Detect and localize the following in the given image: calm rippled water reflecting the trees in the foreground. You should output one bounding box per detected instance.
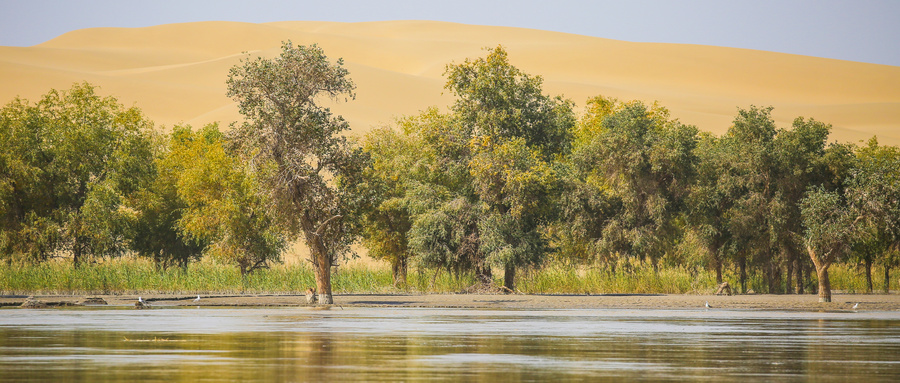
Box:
[0,308,900,382]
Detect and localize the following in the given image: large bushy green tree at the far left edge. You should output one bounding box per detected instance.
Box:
[0,83,153,266]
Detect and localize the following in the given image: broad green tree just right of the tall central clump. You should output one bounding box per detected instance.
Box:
[573,99,697,272]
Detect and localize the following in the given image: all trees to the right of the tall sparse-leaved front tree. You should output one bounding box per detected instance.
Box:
[359,47,900,301]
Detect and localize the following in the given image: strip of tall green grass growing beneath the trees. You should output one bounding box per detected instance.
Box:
[0,257,888,295]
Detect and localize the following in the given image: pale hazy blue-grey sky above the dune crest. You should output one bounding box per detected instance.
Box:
[0,0,900,66]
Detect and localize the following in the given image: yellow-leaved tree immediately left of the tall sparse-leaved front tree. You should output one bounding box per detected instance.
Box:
[170,124,285,276]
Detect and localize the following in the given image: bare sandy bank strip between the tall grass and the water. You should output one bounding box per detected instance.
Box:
[0,294,900,311]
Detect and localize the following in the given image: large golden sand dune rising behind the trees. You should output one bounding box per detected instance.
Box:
[0,21,900,145]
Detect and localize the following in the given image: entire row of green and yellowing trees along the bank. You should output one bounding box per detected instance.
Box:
[0,42,900,303]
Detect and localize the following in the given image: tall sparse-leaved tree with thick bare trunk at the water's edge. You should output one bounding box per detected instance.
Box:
[226,41,363,304]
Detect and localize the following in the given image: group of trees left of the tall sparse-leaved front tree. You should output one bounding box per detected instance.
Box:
[0,84,285,272]
